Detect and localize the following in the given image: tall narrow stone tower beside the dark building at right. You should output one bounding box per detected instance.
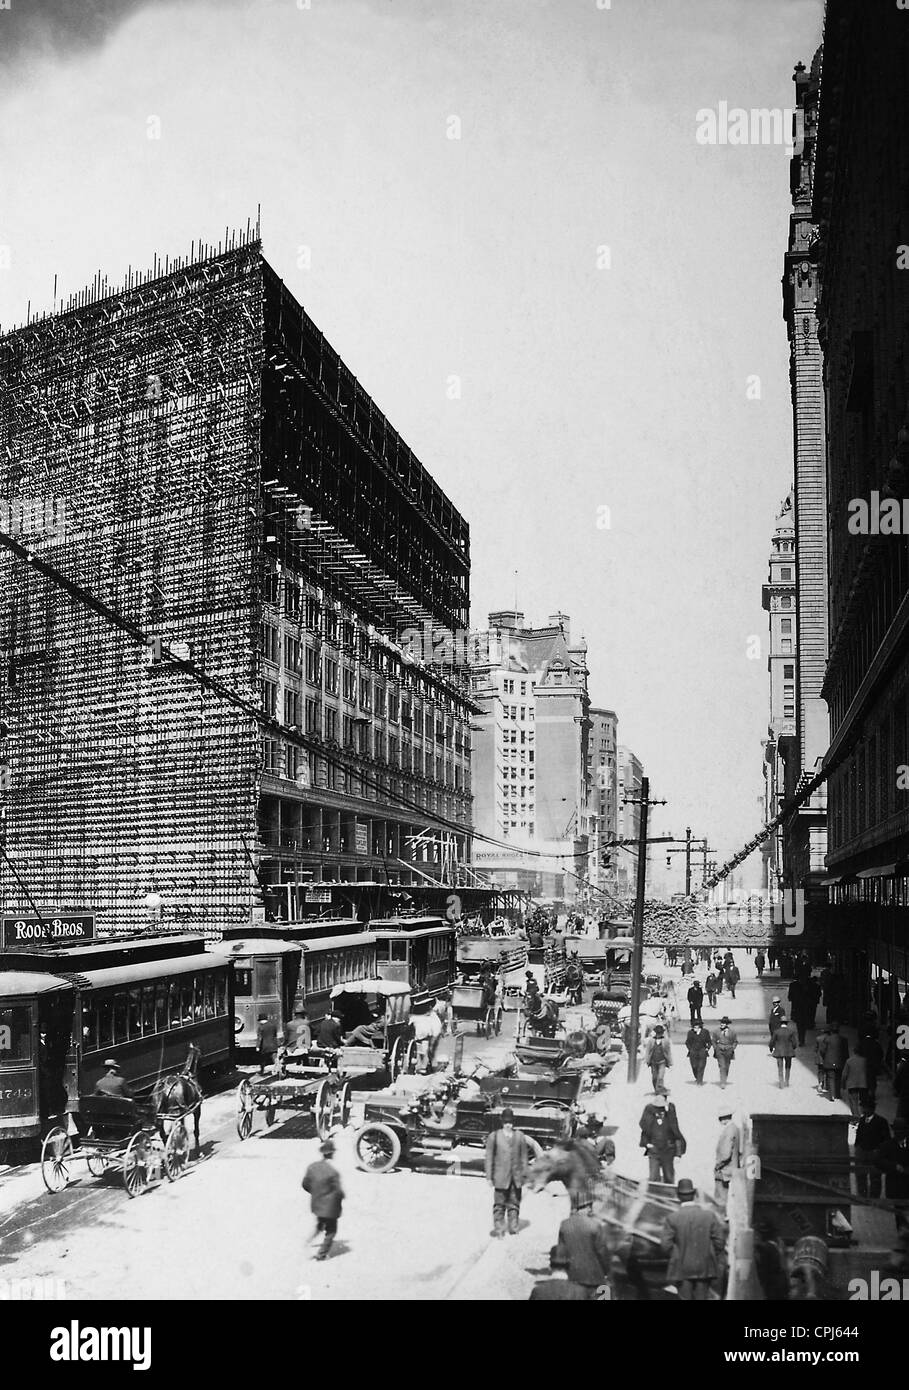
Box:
[769,51,830,899]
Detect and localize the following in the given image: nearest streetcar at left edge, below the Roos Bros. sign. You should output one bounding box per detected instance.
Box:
[0,935,234,1143]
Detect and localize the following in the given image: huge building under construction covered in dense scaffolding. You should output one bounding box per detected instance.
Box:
[0,236,471,930]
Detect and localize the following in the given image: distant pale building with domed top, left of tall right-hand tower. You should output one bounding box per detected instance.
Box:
[762,493,798,892]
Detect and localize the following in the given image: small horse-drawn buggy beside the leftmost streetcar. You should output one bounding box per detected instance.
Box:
[42,1095,190,1197]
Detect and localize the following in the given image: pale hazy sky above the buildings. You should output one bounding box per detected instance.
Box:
[0,0,823,890]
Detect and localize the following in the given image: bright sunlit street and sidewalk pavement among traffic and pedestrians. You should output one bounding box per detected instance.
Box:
[0,951,845,1301]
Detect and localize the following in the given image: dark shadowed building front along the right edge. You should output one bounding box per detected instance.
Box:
[812,0,909,1008]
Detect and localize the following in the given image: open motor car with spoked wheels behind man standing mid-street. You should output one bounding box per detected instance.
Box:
[353,1077,580,1173]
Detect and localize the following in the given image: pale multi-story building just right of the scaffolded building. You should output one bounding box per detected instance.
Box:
[473,610,589,899]
